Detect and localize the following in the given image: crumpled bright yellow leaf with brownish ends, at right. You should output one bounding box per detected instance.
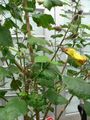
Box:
[62,48,88,65]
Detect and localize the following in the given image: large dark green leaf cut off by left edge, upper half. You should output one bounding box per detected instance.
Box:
[0,25,13,47]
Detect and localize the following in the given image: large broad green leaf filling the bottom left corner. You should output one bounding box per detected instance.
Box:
[0,98,27,120]
